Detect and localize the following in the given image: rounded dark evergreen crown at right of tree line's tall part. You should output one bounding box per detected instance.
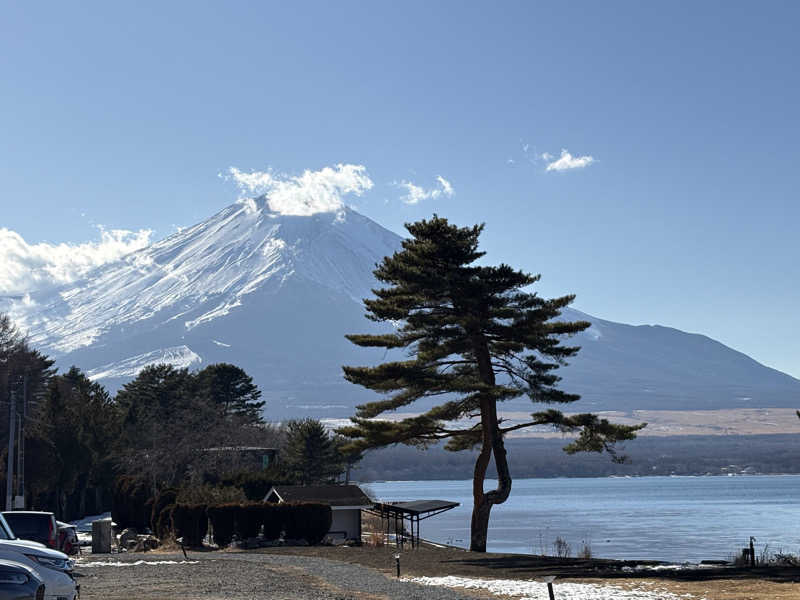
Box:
[195,363,265,423]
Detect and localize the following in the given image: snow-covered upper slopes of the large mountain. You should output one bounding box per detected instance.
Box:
[14,197,400,355]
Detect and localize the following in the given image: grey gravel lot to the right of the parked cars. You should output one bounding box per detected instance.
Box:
[76,552,497,600]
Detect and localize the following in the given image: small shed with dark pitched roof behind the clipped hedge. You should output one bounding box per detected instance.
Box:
[264,484,374,541]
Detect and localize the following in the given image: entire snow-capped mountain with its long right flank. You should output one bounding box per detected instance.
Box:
[0,197,800,419]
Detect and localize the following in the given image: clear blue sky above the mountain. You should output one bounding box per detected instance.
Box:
[0,2,800,376]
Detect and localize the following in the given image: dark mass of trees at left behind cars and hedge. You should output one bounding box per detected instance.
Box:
[0,315,360,520]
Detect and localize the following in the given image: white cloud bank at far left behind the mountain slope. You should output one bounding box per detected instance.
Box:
[0,227,153,295]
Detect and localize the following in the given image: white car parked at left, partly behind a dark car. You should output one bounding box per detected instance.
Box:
[0,515,79,600]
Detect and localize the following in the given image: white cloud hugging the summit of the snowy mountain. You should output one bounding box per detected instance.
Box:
[228,164,373,216]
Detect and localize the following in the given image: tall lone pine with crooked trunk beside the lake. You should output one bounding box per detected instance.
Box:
[339,215,644,552]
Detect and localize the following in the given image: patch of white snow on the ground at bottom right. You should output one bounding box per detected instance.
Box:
[406,576,706,600]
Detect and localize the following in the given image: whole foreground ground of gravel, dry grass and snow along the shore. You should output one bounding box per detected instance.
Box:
[76,546,800,600]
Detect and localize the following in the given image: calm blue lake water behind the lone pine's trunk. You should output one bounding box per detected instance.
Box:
[365,475,800,562]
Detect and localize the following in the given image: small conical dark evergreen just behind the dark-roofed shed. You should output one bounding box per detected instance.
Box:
[281,419,345,485]
